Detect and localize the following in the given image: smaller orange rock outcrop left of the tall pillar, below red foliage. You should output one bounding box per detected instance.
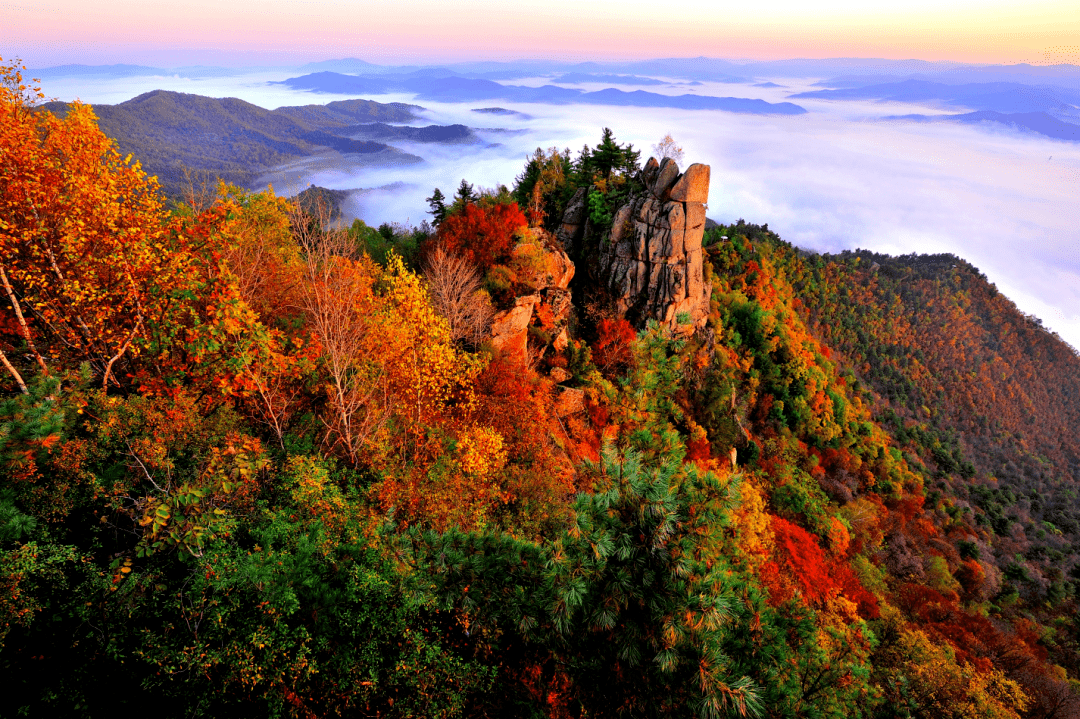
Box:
[491,229,575,364]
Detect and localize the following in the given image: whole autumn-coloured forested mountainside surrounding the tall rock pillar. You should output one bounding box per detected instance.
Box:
[6,60,1080,719]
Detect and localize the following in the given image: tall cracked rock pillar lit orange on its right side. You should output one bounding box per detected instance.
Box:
[599,158,712,335]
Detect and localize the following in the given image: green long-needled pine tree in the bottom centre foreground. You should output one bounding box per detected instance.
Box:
[414,440,761,717]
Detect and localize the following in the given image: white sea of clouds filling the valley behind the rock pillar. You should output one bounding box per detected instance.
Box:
[44,70,1080,348]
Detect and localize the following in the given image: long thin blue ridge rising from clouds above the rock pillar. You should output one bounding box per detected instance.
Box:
[280,71,806,114]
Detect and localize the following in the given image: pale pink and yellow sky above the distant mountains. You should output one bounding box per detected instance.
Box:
[6,0,1080,67]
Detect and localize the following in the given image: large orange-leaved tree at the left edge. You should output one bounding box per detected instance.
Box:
[0,58,191,385]
